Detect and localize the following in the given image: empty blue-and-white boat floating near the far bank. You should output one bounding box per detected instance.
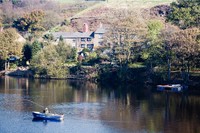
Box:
[157,84,186,92]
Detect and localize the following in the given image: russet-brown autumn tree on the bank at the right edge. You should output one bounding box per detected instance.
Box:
[162,28,200,80]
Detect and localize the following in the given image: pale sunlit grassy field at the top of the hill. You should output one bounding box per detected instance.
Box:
[54,0,175,17]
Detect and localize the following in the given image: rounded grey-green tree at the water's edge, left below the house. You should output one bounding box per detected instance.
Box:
[31,45,68,78]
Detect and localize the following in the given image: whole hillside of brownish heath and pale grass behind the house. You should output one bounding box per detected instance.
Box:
[0,0,173,32]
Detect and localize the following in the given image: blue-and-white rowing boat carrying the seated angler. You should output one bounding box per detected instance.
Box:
[32,111,64,121]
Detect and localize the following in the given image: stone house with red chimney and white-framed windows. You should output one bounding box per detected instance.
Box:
[52,24,106,51]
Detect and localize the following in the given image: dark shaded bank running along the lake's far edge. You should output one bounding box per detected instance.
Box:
[0,66,200,90]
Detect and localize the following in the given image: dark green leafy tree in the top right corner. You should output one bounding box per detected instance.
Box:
[167,0,200,29]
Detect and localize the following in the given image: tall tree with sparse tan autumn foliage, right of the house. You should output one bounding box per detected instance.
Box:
[105,10,146,66]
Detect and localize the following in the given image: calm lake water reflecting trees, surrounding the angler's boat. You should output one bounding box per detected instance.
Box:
[0,77,200,133]
